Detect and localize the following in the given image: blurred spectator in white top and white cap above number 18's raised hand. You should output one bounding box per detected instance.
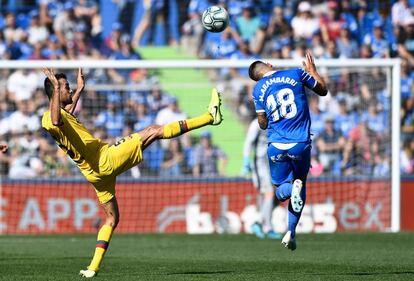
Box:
[291,1,320,41]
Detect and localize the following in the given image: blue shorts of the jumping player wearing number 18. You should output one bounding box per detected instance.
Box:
[267,142,312,185]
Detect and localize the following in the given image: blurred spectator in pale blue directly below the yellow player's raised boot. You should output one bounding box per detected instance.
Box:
[193,132,227,177]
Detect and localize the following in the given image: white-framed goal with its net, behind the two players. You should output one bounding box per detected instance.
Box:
[0,59,400,234]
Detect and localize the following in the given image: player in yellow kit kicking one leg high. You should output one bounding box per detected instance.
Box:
[42,68,222,278]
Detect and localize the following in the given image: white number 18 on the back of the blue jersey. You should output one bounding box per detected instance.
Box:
[266,88,298,121]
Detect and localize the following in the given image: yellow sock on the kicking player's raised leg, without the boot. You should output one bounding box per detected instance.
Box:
[163,113,213,139]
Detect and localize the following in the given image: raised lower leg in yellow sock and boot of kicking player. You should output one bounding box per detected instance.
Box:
[161,89,223,139]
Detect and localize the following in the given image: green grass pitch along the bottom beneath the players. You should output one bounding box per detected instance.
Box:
[0,233,414,281]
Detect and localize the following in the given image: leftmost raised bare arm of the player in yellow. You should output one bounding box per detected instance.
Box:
[43,68,62,126]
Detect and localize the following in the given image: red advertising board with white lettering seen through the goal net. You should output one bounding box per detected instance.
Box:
[0,178,391,234]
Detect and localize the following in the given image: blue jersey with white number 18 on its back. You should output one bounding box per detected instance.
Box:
[253,68,317,143]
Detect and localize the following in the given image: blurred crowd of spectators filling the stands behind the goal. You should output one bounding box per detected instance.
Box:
[0,0,414,178]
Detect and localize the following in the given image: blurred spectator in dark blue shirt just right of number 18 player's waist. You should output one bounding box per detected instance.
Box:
[316,117,345,174]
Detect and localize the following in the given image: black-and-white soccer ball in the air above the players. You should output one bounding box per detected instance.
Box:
[201,6,229,32]
